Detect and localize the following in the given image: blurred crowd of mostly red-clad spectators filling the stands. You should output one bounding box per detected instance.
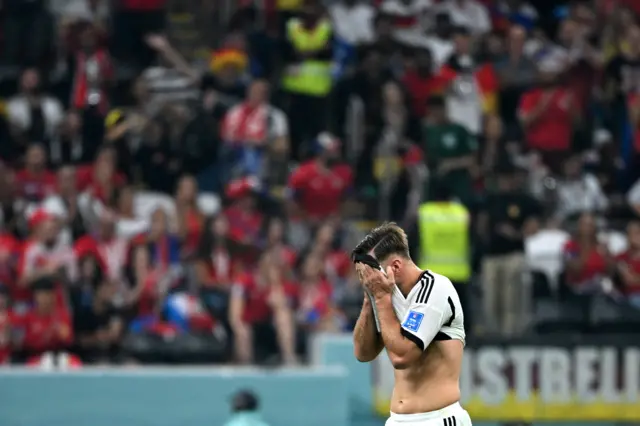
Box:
[0,0,640,364]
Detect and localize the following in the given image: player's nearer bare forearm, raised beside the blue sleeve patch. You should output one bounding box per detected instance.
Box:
[375,294,419,365]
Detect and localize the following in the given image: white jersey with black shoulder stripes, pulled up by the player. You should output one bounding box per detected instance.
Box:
[391,270,465,350]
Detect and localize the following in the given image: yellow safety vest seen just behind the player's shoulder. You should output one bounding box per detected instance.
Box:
[418,202,471,282]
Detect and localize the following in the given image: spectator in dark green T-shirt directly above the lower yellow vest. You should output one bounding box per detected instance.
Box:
[422,96,478,205]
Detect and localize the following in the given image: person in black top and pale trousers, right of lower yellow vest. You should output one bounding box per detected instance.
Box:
[478,160,542,336]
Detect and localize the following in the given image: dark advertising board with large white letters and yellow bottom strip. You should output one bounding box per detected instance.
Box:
[374,338,640,421]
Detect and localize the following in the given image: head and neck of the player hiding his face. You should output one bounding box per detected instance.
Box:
[351,222,422,288]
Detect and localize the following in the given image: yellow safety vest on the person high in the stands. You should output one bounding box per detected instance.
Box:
[282,19,331,97]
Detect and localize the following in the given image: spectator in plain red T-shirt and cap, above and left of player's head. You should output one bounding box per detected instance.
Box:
[288,133,353,223]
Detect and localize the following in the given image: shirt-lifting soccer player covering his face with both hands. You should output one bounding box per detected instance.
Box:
[352,223,471,426]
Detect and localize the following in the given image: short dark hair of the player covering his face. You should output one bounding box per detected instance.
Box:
[351,222,411,262]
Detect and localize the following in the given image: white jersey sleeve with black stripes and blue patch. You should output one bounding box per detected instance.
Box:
[400,274,452,351]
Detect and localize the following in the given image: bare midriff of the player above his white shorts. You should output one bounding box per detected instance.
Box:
[391,340,463,414]
